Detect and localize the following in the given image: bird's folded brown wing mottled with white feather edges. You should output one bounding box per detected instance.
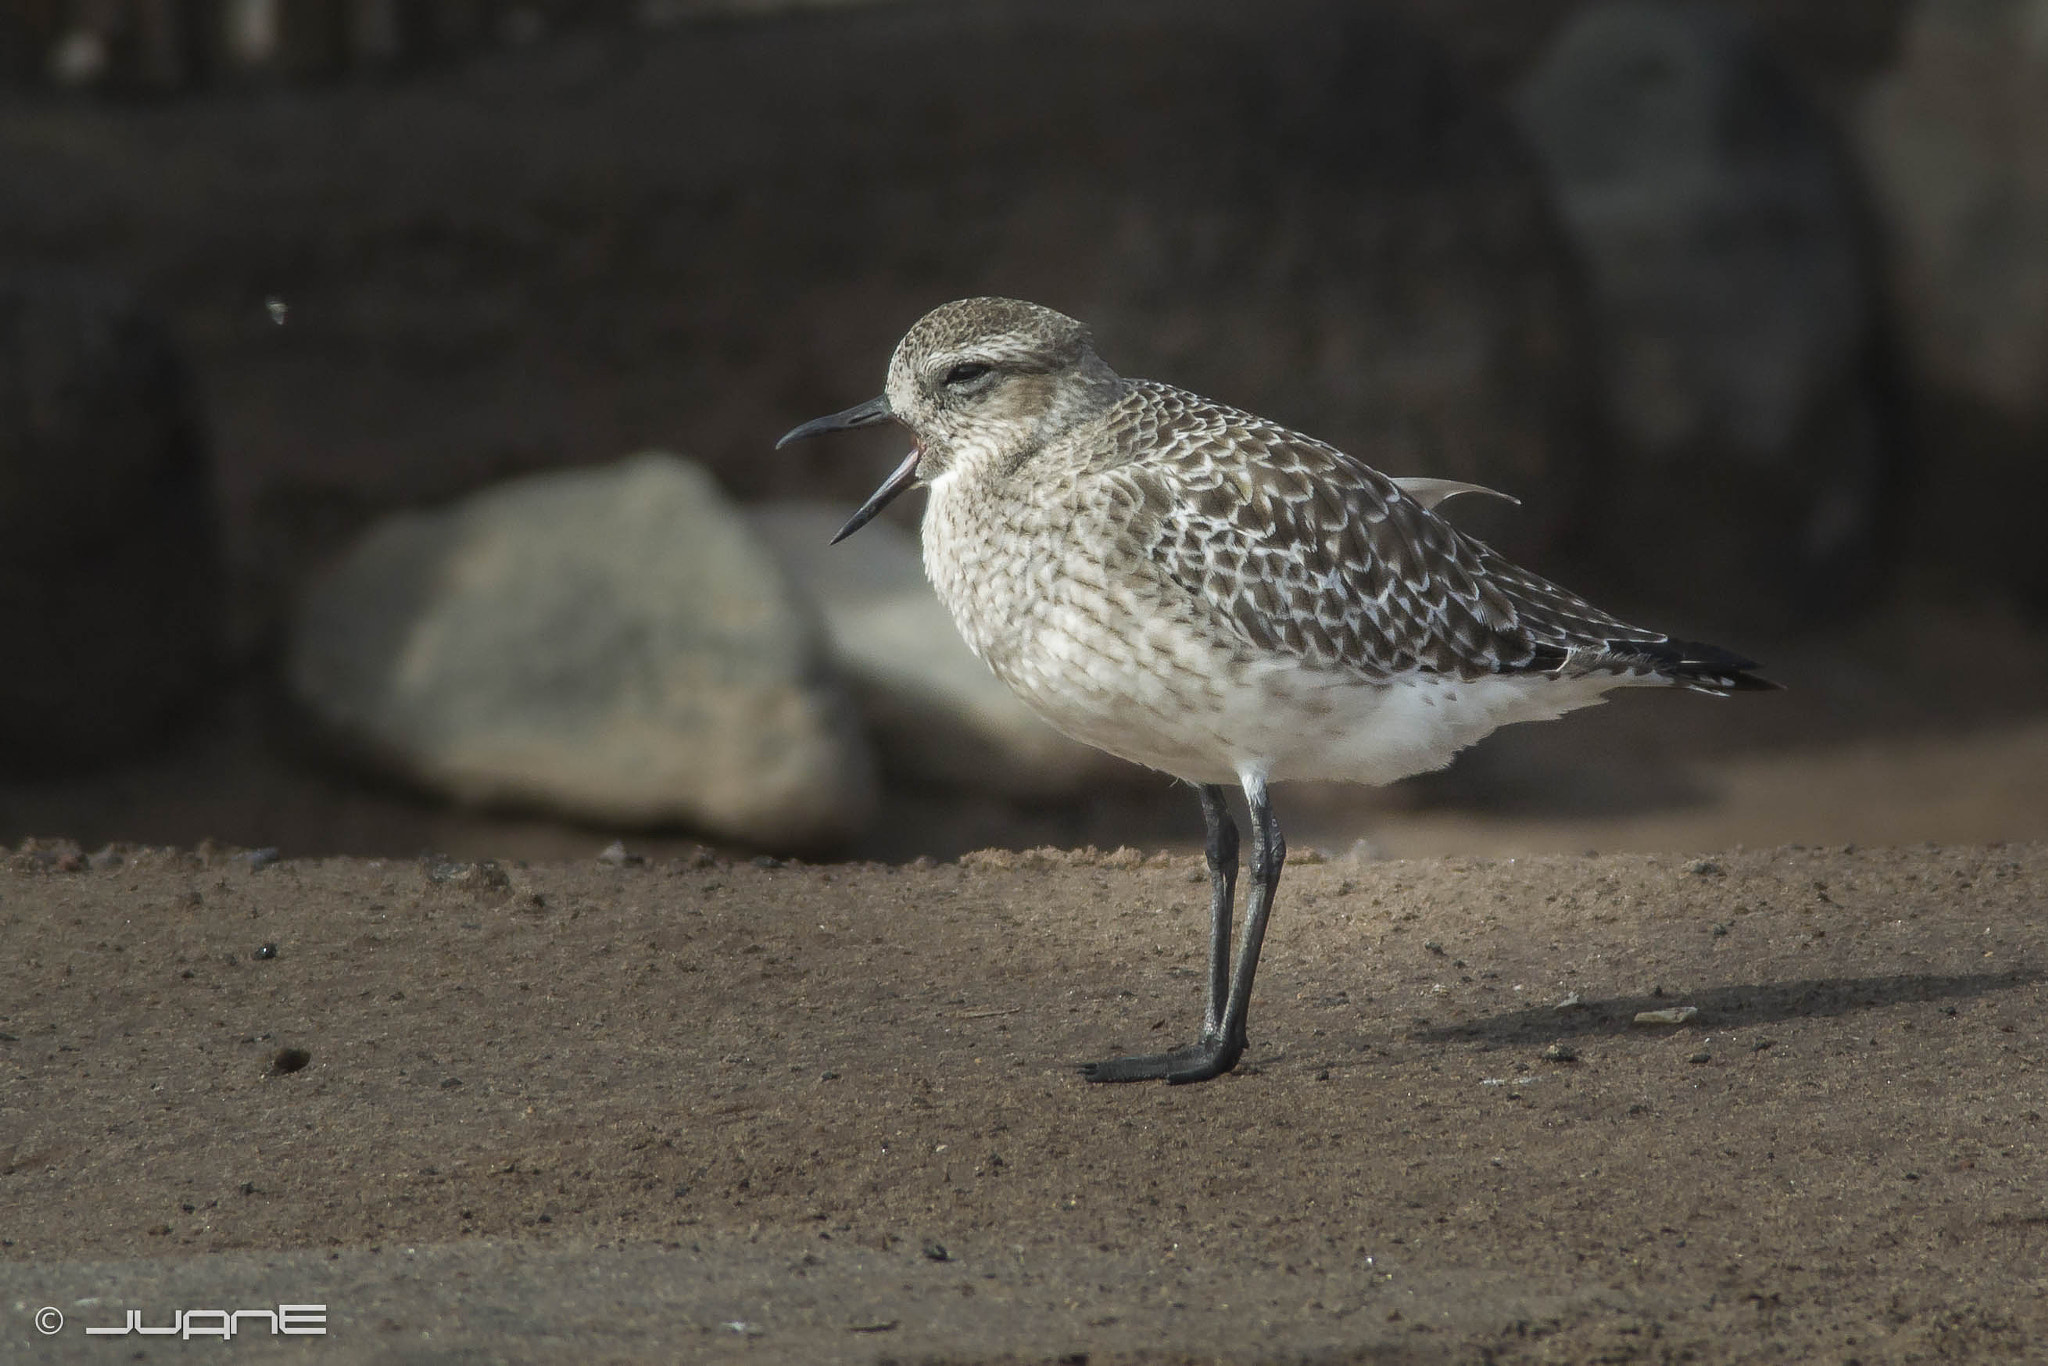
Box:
[1100,383,1749,690]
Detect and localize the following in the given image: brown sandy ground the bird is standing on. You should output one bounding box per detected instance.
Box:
[0,844,2048,1366]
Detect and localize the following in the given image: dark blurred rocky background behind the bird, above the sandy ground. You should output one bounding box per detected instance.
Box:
[0,0,2048,858]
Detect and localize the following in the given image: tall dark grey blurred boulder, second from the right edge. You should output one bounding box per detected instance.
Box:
[1516,2,1898,616]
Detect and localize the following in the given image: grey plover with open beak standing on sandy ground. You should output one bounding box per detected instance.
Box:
[776,299,1776,1081]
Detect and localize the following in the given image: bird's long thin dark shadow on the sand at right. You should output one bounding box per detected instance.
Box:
[1409,967,2048,1044]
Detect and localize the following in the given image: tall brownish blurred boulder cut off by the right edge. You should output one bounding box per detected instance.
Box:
[1860,0,2048,612]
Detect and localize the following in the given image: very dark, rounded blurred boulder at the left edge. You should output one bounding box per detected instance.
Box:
[0,272,221,770]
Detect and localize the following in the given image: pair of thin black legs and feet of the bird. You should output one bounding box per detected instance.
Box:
[1081,778,1286,1083]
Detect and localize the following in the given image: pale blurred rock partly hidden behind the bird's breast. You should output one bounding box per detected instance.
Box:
[750,502,1139,801]
